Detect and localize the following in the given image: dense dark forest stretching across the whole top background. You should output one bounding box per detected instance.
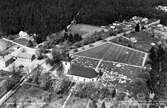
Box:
[0,0,167,43]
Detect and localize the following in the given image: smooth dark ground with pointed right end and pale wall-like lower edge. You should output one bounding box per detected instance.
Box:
[68,64,98,78]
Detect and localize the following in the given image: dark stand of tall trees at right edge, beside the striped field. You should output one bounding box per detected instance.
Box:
[147,46,167,101]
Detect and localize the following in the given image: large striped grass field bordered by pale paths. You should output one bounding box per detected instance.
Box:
[74,43,145,66]
